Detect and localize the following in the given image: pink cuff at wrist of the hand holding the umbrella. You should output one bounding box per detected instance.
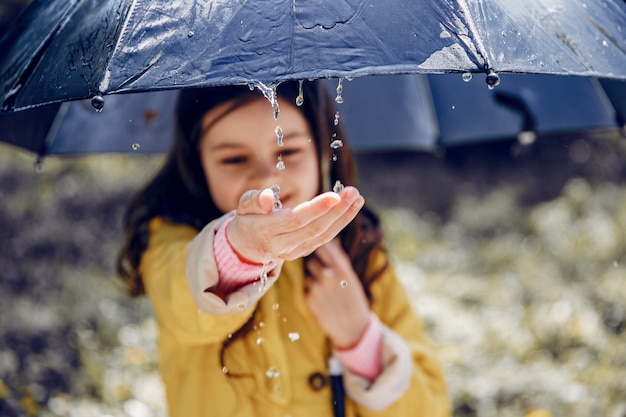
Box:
[333,313,383,382]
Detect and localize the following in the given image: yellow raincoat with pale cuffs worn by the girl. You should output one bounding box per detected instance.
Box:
[141,214,449,417]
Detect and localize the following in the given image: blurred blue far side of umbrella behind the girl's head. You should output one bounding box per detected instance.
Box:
[0,74,626,155]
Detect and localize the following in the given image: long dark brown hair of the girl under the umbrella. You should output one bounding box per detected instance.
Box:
[117,81,382,298]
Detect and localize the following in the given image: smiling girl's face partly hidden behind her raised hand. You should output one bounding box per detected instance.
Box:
[200,97,319,213]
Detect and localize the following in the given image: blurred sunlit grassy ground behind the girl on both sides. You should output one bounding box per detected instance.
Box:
[0,131,626,417]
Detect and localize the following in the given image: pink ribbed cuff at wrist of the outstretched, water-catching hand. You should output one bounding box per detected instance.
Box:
[213,217,274,294]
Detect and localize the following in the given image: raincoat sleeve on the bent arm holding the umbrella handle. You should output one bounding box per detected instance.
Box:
[344,251,450,417]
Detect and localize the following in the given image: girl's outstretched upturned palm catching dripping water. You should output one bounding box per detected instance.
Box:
[226,187,364,263]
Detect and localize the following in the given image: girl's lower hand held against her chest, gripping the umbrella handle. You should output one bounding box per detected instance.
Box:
[306,239,370,349]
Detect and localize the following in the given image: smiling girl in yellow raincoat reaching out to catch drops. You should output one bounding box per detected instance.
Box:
[118,82,449,417]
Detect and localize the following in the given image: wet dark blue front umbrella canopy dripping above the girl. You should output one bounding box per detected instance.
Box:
[0,0,626,112]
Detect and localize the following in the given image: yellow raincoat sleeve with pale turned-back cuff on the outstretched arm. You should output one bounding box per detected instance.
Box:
[140,214,281,345]
